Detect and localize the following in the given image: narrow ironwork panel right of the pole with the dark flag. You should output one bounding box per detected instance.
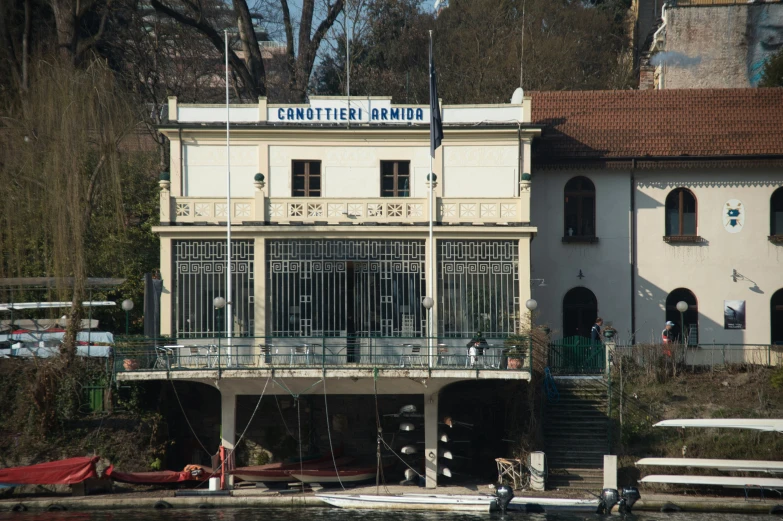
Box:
[437,240,519,337]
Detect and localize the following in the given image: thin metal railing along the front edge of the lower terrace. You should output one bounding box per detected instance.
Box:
[114,337,532,373]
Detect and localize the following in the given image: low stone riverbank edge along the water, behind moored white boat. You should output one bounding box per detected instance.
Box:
[0,486,783,514]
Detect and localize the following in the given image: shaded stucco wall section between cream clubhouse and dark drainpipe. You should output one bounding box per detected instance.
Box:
[531,170,631,341]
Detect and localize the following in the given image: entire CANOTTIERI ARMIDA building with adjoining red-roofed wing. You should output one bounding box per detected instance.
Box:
[118,89,783,487]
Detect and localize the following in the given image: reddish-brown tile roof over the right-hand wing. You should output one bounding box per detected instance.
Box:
[530,88,783,162]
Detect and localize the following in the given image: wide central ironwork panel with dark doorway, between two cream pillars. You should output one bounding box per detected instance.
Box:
[267,240,426,337]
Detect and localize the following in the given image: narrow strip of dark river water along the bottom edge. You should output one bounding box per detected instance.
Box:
[0,507,780,521]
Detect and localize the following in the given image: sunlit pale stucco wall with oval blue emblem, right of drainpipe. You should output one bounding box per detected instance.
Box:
[636,170,783,344]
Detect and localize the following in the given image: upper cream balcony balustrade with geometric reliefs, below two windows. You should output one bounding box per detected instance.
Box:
[161,196,530,224]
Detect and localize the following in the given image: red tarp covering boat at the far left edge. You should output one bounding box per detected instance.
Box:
[0,456,100,485]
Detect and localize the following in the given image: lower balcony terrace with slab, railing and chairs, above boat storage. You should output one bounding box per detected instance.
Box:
[114,337,532,380]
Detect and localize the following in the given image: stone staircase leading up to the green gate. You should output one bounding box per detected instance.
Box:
[543,376,610,493]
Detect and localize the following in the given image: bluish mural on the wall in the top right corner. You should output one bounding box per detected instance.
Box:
[745,3,783,87]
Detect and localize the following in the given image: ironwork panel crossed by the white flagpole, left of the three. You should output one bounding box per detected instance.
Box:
[174,240,254,338]
